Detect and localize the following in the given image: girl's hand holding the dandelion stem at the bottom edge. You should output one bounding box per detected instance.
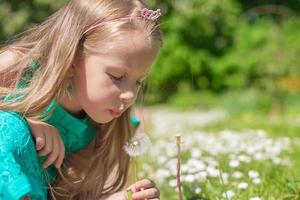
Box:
[128,179,160,200]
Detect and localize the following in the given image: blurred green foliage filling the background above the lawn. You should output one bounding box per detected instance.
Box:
[0,0,300,107]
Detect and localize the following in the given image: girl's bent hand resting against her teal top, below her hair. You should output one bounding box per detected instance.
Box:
[27,119,65,168]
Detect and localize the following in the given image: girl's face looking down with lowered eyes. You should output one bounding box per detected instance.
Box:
[63,30,159,123]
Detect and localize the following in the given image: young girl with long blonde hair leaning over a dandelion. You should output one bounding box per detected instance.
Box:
[0,0,162,200]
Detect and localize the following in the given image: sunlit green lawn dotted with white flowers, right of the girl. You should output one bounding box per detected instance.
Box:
[142,91,300,200]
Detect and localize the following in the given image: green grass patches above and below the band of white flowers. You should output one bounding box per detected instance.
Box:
[142,91,300,200]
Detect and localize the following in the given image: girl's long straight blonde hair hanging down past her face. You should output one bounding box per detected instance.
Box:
[0,0,162,199]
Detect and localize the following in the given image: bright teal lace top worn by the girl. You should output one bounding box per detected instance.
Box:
[0,62,139,200]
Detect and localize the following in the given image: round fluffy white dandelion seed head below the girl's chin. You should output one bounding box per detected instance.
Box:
[123,133,151,157]
